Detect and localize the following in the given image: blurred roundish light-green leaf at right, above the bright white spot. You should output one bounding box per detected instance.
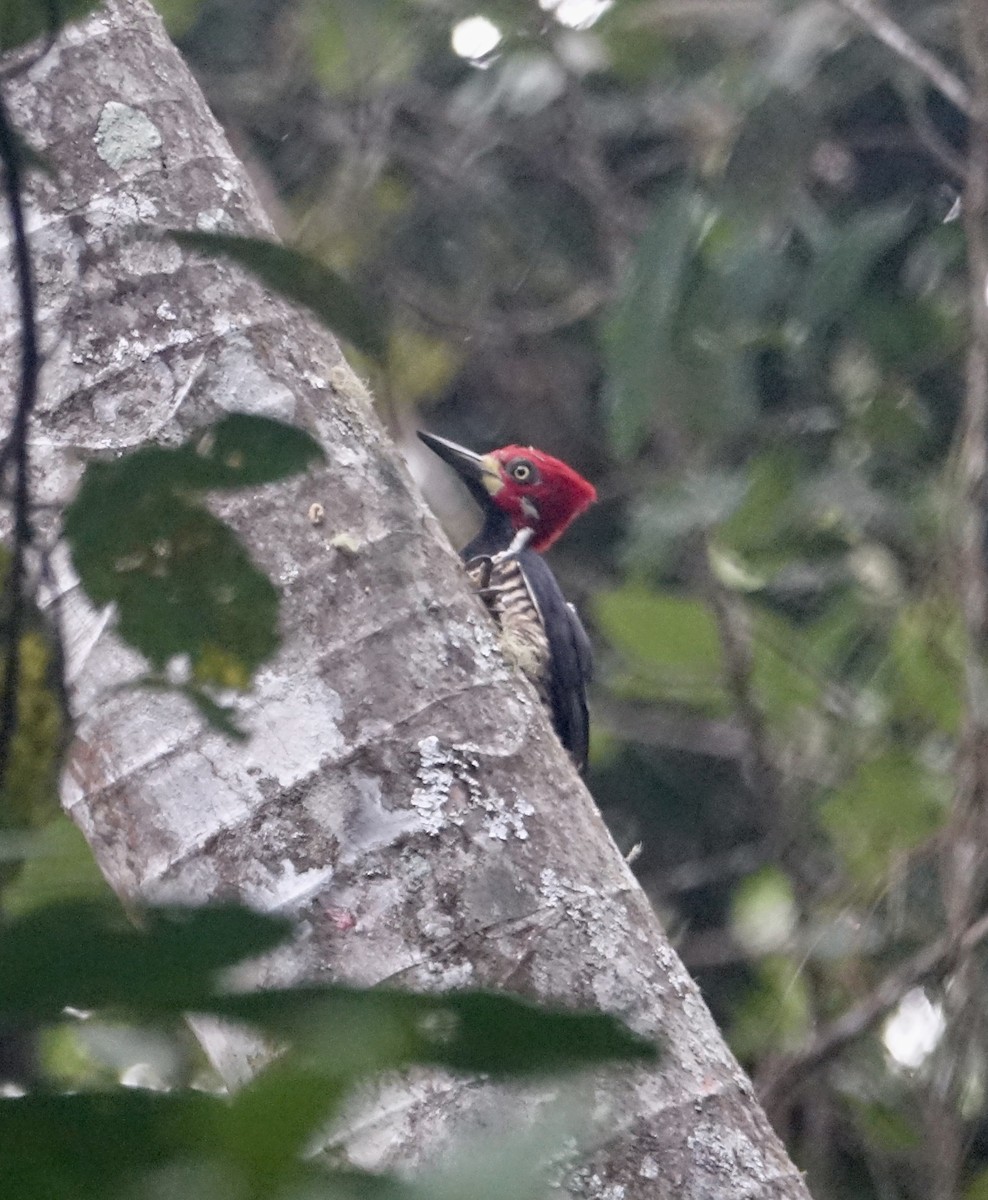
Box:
[820,748,950,888]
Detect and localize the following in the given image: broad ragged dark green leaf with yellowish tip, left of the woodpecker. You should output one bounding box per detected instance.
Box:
[65,414,322,691]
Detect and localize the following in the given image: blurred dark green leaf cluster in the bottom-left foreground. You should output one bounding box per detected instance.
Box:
[0,900,655,1200]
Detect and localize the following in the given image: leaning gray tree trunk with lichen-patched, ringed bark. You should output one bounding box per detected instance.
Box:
[0,0,806,1200]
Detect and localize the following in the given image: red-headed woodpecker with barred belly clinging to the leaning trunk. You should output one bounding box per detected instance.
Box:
[419,433,597,773]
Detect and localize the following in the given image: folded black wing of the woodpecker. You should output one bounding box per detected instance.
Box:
[519,551,593,773]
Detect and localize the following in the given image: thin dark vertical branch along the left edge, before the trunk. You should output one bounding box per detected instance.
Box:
[0,95,41,787]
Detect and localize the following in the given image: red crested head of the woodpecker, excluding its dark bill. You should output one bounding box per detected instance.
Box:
[484,446,597,551]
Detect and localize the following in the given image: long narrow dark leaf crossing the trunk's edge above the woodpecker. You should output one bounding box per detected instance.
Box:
[168,229,385,362]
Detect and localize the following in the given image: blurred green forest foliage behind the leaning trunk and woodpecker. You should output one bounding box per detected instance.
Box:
[6,0,988,1200]
